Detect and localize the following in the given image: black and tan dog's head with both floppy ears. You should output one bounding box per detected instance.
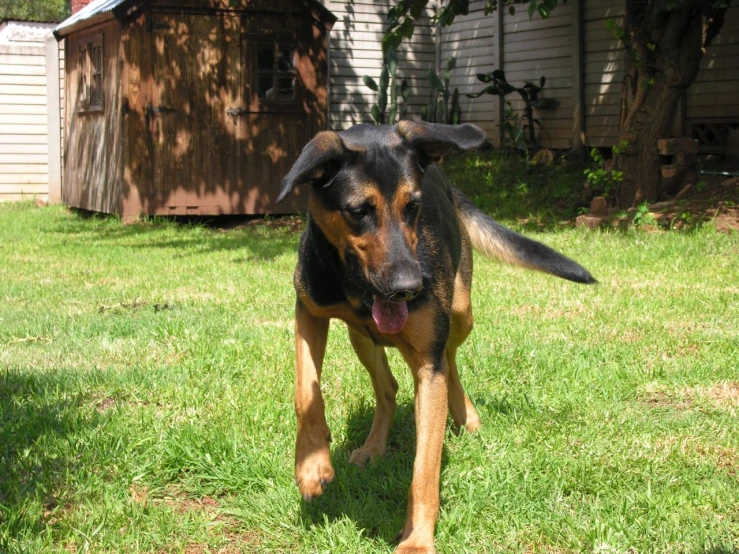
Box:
[277,121,485,328]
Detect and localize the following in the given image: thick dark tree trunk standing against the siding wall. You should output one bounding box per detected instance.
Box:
[614,0,731,208]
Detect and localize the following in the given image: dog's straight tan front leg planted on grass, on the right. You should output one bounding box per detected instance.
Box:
[395,355,449,554]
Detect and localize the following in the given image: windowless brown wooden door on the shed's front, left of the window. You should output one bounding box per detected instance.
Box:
[145,13,243,215]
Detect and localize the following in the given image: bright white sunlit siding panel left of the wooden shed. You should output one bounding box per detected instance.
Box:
[0,43,49,201]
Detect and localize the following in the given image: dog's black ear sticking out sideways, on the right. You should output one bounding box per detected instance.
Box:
[396,121,485,162]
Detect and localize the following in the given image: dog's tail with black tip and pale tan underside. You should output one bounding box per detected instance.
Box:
[453,188,597,283]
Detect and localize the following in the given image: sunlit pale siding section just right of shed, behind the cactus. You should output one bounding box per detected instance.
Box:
[324,0,436,130]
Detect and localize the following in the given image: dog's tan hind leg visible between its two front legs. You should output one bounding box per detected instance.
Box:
[348,327,398,467]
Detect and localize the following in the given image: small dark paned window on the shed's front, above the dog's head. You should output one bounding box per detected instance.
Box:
[257,43,296,102]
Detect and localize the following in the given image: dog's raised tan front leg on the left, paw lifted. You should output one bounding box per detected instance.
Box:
[295,301,334,502]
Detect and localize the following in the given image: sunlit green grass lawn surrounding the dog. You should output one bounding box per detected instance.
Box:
[0,191,739,554]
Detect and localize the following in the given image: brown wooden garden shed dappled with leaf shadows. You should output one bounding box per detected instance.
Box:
[55,0,336,217]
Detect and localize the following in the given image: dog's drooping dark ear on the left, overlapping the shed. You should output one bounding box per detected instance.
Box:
[277,131,344,203]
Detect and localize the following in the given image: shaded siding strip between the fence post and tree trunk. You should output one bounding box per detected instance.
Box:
[583,0,626,146]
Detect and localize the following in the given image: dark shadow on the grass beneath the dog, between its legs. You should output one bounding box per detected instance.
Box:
[301,402,448,545]
